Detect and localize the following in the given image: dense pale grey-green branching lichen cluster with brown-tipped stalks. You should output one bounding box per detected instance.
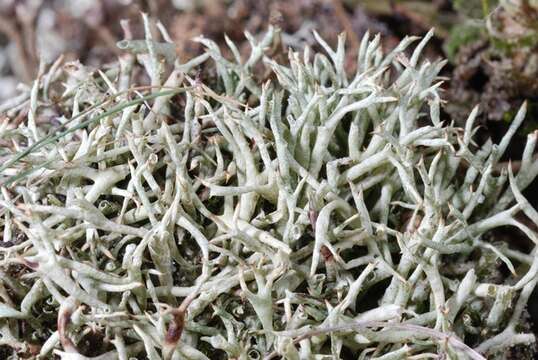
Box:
[0,19,538,360]
